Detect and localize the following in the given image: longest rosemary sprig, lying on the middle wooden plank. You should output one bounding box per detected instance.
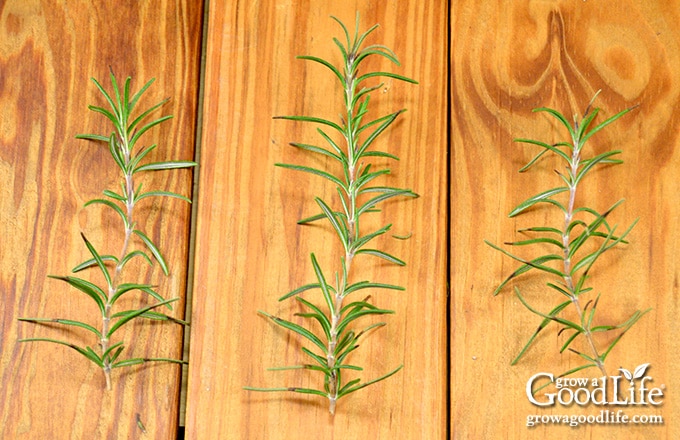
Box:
[245,15,417,414]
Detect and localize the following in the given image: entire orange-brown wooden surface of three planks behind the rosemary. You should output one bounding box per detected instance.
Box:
[5,0,680,439]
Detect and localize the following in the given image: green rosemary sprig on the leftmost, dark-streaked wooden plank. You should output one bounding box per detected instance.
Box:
[19,72,196,390]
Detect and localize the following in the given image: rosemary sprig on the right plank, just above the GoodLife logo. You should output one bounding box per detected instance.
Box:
[486,92,650,382]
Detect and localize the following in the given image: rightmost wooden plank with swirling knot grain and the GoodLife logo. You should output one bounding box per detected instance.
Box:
[450,0,680,439]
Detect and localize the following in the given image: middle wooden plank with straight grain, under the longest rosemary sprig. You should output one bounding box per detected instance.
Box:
[187,0,447,439]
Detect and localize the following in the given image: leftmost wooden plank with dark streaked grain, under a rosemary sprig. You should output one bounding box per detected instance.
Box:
[0,0,202,439]
